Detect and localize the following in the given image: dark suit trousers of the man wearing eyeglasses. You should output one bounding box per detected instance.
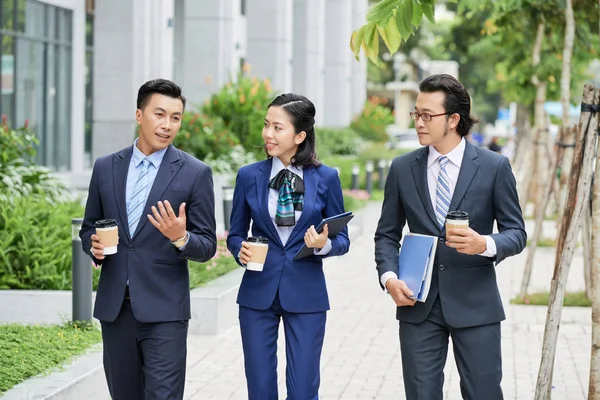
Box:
[400,297,503,400]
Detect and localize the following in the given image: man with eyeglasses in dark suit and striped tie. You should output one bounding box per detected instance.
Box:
[375,74,527,400]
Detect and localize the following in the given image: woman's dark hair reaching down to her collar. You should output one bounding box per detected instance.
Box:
[265,93,321,167]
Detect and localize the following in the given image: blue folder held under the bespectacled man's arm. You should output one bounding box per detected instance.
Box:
[398,233,438,302]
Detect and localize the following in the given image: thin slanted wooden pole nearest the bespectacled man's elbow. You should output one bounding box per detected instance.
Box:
[519,129,565,298]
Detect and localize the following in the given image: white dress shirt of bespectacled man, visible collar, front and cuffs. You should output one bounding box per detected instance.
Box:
[381,138,496,287]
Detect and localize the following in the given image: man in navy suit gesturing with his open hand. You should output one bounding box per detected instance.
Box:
[80,79,217,400]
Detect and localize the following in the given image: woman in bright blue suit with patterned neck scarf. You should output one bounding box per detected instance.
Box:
[227,93,350,400]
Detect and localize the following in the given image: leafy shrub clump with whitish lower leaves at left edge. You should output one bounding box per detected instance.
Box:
[0,124,67,202]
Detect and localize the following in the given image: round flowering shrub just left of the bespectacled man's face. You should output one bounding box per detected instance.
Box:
[350,97,394,142]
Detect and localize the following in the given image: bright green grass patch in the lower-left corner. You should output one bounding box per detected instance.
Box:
[0,322,102,393]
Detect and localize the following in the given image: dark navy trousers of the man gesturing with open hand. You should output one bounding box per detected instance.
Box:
[100,299,188,400]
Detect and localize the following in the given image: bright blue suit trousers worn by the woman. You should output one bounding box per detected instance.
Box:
[239,295,326,400]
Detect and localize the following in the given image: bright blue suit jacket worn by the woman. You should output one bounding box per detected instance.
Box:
[227,158,350,313]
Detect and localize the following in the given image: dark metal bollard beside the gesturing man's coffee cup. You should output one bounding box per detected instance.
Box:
[71,218,92,321]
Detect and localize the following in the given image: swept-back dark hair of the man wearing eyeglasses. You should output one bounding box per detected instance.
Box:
[419,74,479,137]
